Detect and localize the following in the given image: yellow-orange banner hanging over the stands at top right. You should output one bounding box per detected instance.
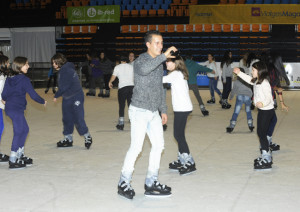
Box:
[190,4,300,24]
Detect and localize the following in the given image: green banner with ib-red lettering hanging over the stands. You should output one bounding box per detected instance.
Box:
[67,5,120,24]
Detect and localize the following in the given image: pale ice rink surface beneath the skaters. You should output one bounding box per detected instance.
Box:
[0,89,300,212]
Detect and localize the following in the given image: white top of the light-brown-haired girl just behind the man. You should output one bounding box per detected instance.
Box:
[163,70,193,112]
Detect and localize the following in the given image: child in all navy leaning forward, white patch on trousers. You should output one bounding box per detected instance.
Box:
[51,53,92,149]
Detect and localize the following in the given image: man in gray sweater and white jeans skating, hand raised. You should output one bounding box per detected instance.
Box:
[118,31,177,199]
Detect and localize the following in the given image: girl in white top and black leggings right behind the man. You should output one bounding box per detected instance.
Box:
[163,56,196,175]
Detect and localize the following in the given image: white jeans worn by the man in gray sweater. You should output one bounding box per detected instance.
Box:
[120,105,164,182]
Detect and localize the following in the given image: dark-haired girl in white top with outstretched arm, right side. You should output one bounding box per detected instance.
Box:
[234,61,275,169]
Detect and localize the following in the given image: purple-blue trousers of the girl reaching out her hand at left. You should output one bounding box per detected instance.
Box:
[5,108,29,152]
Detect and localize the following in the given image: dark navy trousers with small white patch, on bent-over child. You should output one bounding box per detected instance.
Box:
[62,92,88,135]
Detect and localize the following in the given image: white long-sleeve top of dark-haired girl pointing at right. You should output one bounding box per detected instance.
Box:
[238,72,274,110]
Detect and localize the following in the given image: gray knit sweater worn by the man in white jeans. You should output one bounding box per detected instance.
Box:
[131,52,167,114]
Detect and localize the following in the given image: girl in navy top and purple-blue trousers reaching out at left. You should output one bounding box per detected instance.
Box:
[2,57,47,169]
